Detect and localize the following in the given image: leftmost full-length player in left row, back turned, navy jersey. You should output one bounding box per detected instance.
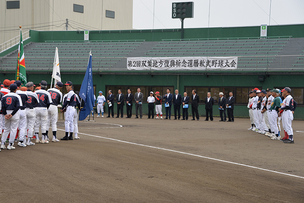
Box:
[0,84,22,150]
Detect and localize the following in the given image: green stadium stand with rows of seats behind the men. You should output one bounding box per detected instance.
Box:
[0,25,304,119]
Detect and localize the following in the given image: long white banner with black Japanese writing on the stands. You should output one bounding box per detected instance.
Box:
[127,57,238,70]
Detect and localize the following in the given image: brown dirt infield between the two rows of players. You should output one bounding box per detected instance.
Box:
[0,117,304,202]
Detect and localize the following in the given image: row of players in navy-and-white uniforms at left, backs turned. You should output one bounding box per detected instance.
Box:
[0,79,80,151]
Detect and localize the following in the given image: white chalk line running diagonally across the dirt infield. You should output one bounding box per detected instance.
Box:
[58,128,304,179]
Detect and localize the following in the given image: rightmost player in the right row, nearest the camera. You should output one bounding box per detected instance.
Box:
[279,87,294,144]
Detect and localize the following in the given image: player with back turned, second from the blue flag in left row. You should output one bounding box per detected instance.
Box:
[46,82,63,142]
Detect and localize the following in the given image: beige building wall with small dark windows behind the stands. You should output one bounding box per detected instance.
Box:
[0,0,133,44]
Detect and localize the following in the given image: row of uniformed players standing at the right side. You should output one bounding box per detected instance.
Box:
[247,87,297,144]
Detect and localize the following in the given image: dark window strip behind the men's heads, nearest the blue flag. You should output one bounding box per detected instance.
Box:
[104,85,174,102]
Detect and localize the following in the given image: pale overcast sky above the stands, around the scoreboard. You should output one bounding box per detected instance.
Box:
[133,0,304,29]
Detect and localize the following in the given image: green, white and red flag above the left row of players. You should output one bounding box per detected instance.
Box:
[16,26,27,84]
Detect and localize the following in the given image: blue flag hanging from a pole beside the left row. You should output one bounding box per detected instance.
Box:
[79,52,94,121]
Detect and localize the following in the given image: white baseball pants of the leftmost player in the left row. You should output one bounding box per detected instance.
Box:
[1,110,20,145]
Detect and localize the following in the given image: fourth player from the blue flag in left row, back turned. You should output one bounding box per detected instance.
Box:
[25,82,39,146]
